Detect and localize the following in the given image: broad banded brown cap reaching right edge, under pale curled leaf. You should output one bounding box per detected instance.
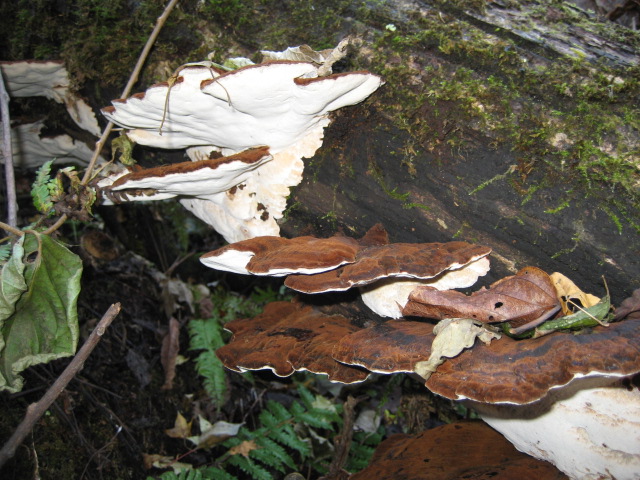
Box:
[426,320,640,404]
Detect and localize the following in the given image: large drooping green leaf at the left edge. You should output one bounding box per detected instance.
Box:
[0,234,82,392]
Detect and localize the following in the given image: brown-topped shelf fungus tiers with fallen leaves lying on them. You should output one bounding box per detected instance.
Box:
[201,226,640,479]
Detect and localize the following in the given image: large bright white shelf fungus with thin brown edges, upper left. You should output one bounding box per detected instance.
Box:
[100,43,383,242]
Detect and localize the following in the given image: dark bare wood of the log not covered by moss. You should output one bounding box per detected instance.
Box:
[282,2,640,303]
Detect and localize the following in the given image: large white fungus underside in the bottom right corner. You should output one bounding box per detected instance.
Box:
[469,377,640,480]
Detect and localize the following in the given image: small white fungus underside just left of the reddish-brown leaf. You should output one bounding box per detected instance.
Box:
[359,257,490,318]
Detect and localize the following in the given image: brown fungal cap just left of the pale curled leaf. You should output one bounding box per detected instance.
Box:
[332,320,434,373]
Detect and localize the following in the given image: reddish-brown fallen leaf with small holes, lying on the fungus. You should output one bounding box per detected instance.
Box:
[402,267,560,333]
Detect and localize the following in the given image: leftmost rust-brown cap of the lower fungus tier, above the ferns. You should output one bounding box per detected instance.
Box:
[216,302,369,383]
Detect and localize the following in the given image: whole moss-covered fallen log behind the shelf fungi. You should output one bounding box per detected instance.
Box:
[2,0,640,303]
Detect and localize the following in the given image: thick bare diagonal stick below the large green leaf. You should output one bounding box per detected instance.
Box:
[0,303,120,468]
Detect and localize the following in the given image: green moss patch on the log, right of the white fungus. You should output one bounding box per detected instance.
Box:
[358,2,640,234]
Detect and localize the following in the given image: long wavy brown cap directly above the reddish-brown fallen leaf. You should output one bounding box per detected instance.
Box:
[285,242,491,293]
